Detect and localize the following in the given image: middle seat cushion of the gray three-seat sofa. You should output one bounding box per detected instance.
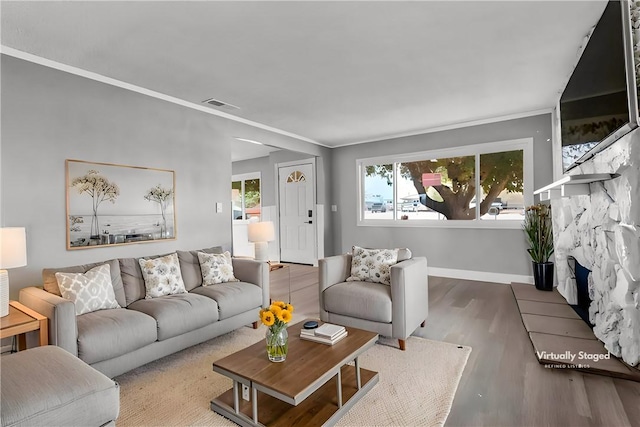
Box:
[129,294,218,341]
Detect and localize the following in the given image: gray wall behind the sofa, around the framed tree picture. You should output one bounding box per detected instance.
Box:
[0,55,336,299]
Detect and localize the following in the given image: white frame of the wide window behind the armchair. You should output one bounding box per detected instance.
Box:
[356,138,533,229]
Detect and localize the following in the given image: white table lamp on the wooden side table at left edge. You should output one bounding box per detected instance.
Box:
[0,227,27,317]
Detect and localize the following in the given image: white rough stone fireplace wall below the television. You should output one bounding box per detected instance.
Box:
[551,129,640,366]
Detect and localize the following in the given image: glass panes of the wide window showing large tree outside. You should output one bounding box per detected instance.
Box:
[364,145,524,220]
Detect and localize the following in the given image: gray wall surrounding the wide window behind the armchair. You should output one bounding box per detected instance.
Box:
[330,114,552,276]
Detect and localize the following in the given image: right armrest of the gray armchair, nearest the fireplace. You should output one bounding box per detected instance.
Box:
[391,257,429,339]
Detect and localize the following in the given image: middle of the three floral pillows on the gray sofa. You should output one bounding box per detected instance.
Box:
[138,253,187,299]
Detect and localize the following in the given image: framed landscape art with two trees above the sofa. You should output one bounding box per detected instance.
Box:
[65,159,176,250]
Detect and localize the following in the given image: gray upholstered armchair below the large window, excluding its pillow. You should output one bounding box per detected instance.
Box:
[319,254,429,350]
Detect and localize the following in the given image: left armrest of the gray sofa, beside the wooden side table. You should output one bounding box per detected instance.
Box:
[18,286,78,356]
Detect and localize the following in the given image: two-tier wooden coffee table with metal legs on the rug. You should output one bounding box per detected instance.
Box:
[211,322,378,426]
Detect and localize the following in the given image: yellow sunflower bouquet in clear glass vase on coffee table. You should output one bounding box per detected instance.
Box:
[260,301,293,362]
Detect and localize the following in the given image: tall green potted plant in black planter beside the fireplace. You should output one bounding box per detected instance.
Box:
[523,203,553,291]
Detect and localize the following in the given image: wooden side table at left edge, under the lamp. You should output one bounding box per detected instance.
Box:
[0,301,49,350]
